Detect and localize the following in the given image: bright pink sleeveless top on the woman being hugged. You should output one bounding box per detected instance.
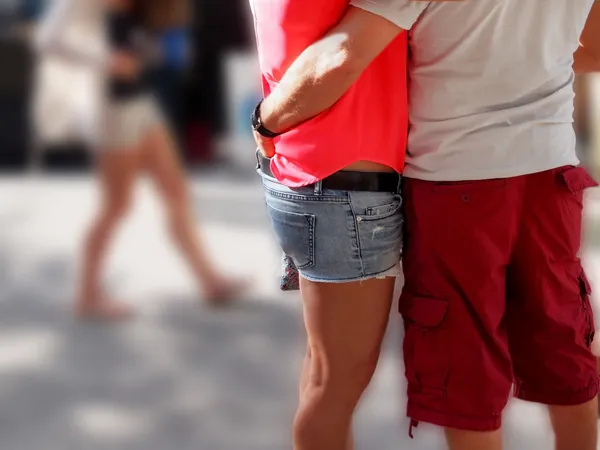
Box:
[251,0,408,187]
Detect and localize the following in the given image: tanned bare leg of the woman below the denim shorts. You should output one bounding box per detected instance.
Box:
[294,278,395,450]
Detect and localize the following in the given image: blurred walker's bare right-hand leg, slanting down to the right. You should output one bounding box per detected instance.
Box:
[144,119,245,302]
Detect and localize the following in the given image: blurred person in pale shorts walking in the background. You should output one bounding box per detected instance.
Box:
[36,0,243,320]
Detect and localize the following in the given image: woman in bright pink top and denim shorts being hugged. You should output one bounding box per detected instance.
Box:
[251,0,408,450]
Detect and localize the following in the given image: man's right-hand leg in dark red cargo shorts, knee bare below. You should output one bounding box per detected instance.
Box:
[506,167,599,450]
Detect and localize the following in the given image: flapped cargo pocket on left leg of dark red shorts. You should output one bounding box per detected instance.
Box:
[400,294,450,396]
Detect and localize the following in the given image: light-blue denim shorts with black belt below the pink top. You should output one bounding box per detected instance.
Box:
[258,169,403,283]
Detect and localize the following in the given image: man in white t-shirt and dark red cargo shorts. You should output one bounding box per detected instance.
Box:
[251,0,600,450]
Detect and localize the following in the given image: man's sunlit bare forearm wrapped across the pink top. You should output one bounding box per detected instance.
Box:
[260,6,402,132]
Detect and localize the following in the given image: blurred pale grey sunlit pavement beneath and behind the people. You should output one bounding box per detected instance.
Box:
[0,171,600,450]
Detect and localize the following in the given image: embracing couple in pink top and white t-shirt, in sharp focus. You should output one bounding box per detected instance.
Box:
[250,0,600,450]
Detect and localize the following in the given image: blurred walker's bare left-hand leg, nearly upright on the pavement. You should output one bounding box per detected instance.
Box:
[76,149,141,319]
